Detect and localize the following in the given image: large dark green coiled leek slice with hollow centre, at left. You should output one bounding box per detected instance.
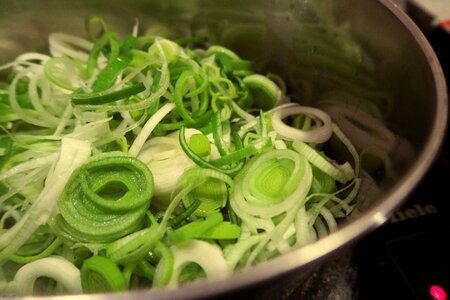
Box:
[58,152,153,243]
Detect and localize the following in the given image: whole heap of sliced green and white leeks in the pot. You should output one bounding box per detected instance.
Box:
[0,16,383,295]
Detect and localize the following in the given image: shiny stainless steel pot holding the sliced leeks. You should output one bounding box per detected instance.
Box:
[0,0,448,299]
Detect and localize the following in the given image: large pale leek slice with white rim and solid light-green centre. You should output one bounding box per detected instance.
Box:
[230,149,312,220]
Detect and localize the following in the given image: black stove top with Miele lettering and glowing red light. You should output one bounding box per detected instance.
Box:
[353,149,450,300]
